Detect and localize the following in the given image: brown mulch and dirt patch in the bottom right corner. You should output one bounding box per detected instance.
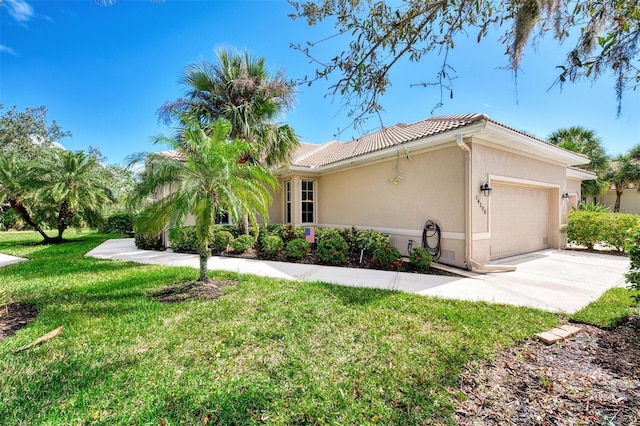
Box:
[455,317,640,425]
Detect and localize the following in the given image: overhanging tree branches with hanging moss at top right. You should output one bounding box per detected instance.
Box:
[289,0,640,121]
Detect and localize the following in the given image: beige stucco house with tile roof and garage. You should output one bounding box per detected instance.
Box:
[269,114,595,269]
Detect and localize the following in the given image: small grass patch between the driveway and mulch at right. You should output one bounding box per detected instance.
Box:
[571,287,638,329]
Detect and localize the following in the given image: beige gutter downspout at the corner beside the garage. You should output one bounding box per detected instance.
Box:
[456,134,516,273]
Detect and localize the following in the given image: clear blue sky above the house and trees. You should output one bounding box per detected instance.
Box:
[0,0,640,163]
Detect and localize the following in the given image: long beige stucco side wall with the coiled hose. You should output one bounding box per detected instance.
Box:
[317,146,464,266]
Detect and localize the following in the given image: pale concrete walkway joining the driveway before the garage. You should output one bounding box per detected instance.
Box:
[87,239,629,313]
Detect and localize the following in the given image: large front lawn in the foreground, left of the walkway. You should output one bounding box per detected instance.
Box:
[0,233,558,425]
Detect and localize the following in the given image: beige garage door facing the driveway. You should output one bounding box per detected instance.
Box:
[491,183,551,260]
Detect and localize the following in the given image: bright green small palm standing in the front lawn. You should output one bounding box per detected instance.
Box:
[134,117,277,281]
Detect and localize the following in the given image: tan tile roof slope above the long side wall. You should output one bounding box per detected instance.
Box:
[291,114,490,167]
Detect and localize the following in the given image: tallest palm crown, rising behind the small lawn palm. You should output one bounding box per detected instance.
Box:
[158,49,299,166]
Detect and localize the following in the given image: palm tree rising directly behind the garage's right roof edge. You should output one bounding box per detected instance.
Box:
[548,126,609,198]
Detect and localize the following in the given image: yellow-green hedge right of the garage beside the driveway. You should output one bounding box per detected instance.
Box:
[567,210,640,252]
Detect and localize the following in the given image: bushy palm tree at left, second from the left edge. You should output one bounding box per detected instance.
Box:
[35,149,116,243]
